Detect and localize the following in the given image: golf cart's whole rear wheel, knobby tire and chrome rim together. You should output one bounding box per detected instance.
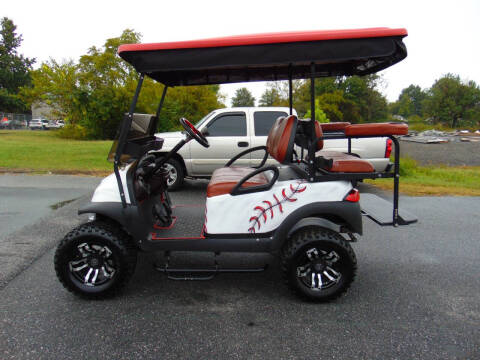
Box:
[281,227,357,302]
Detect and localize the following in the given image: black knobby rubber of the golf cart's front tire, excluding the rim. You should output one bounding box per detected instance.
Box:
[54,221,137,299]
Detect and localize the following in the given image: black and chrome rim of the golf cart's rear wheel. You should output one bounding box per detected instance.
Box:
[296,247,342,291]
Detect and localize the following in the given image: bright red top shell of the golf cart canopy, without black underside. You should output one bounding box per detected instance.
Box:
[118,27,408,54]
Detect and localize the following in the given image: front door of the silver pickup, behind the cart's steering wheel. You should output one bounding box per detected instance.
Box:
[190,111,250,176]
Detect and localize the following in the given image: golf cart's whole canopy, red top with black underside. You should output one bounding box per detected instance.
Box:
[118,28,407,86]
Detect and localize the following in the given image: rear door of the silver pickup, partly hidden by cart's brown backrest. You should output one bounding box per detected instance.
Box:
[251,110,288,166]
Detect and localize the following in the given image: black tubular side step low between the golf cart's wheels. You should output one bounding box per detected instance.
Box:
[154,252,268,281]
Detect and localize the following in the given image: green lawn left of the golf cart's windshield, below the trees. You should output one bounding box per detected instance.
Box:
[0,130,112,175]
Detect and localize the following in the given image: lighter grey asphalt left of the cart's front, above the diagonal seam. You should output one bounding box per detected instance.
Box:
[0,174,101,287]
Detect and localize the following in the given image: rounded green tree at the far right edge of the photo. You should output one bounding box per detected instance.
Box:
[423,74,480,128]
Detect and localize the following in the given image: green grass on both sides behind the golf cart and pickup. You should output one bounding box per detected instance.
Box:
[0,130,480,196]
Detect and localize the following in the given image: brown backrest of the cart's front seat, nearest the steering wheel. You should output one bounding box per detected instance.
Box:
[267,115,298,164]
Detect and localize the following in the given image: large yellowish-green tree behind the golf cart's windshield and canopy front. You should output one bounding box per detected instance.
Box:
[21,30,223,139]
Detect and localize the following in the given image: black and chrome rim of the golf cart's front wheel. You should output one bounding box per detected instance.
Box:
[68,242,117,287]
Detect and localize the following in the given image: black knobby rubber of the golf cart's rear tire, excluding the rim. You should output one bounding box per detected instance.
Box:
[281,227,357,302]
